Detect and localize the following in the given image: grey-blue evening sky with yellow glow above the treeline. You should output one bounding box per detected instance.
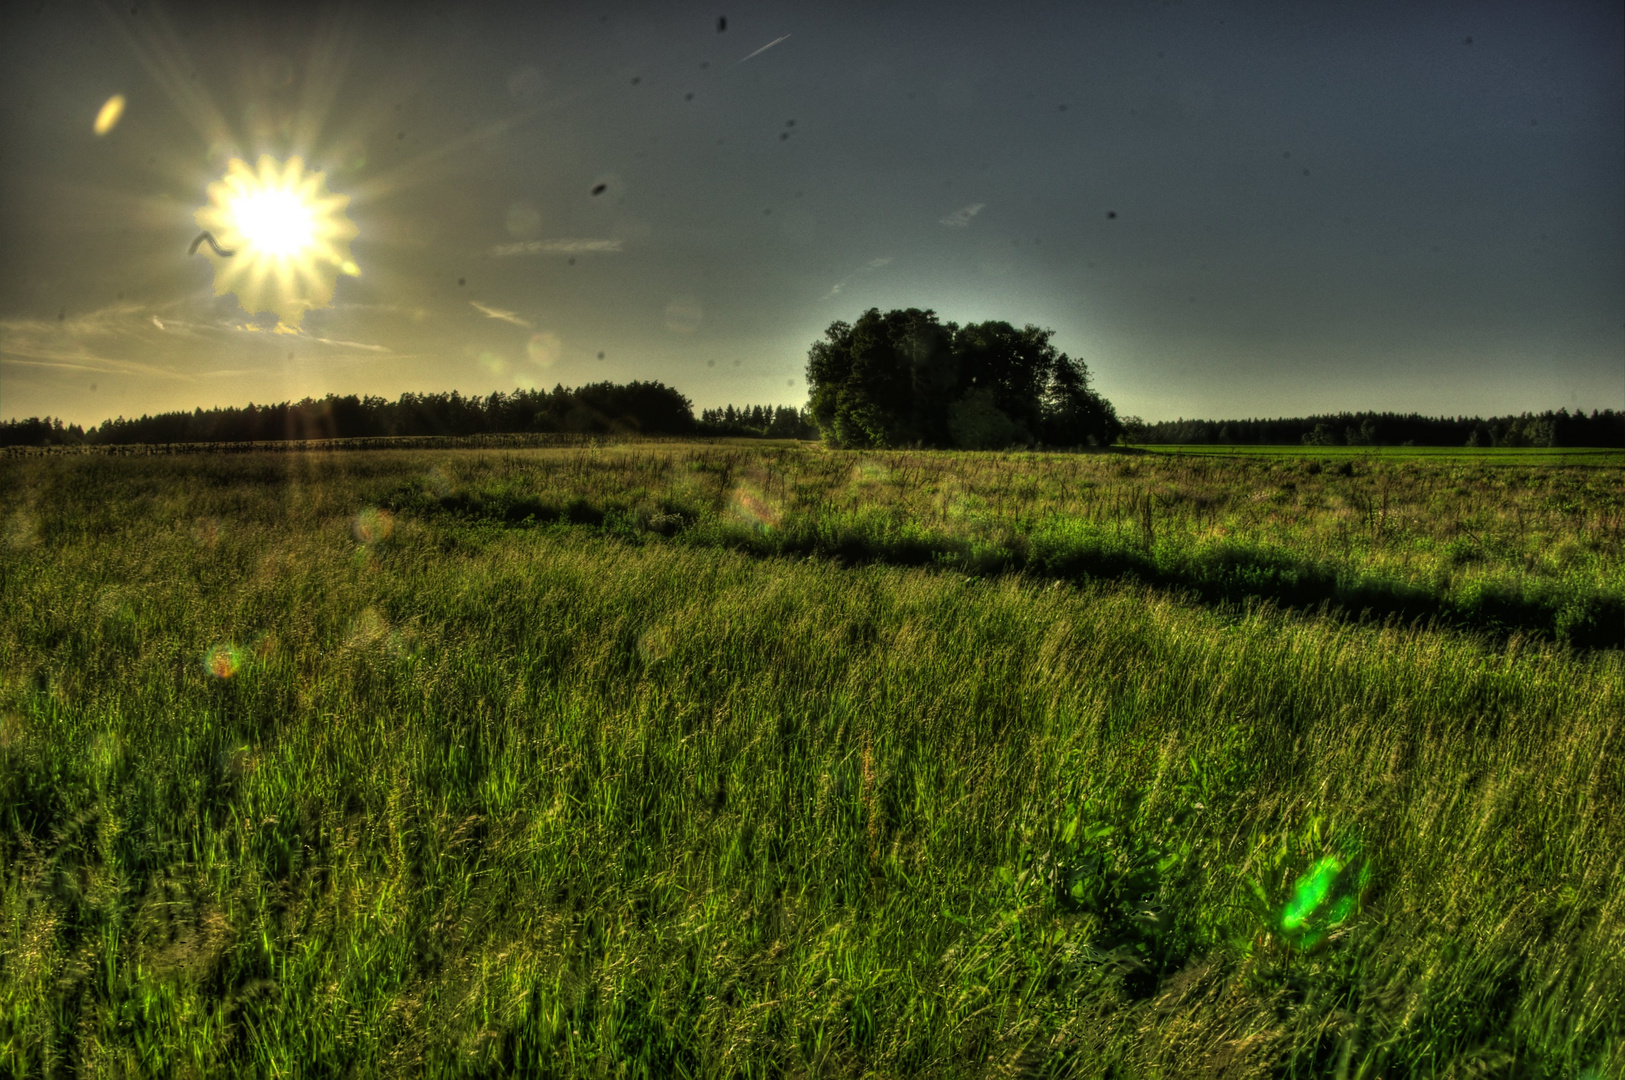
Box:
[0,0,1625,424]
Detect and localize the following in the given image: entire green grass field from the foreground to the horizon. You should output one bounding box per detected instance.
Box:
[0,445,1625,1078]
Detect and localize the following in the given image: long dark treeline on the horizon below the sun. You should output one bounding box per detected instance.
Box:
[0,382,696,447]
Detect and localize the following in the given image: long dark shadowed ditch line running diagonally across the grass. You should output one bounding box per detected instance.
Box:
[388,492,1625,648]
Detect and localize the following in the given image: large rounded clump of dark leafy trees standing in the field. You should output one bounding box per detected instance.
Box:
[808,309,1121,450]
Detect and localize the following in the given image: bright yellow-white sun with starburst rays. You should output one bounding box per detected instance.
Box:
[195,154,361,331]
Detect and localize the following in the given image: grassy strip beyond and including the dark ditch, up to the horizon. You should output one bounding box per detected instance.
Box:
[385,447,1625,646]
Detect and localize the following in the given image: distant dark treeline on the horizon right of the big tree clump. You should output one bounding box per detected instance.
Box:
[1123,409,1625,447]
